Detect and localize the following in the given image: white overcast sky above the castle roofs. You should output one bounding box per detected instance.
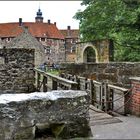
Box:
[0,1,84,29]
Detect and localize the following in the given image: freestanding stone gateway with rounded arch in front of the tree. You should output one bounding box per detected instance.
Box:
[76,40,113,63]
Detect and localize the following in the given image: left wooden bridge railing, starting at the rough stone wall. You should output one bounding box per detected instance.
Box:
[34,68,78,92]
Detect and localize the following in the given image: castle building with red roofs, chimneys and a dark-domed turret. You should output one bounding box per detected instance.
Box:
[0,8,79,63]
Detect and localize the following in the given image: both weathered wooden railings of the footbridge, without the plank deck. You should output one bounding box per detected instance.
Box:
[34,69,129,114]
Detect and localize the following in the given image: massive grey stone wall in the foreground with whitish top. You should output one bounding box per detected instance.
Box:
[0,90,90,140]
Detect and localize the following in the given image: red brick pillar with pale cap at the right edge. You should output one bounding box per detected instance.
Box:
[130,77,140,116]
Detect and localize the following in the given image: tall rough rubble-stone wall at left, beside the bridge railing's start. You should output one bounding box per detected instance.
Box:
[0,48,34,93]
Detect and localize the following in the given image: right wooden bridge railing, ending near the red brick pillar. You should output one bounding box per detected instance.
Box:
[61,73,129,114]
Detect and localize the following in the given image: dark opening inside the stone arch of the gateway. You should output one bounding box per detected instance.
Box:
[83,46,96,63]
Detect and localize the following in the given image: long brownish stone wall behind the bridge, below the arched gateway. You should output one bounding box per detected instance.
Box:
[62,62,140,88]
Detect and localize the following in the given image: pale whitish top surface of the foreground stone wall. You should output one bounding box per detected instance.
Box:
[0,90,87,104]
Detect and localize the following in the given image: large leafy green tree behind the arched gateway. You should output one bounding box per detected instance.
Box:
[75,0,140,61]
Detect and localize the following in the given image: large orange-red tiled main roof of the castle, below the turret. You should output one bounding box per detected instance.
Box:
[0,22,64,39]
